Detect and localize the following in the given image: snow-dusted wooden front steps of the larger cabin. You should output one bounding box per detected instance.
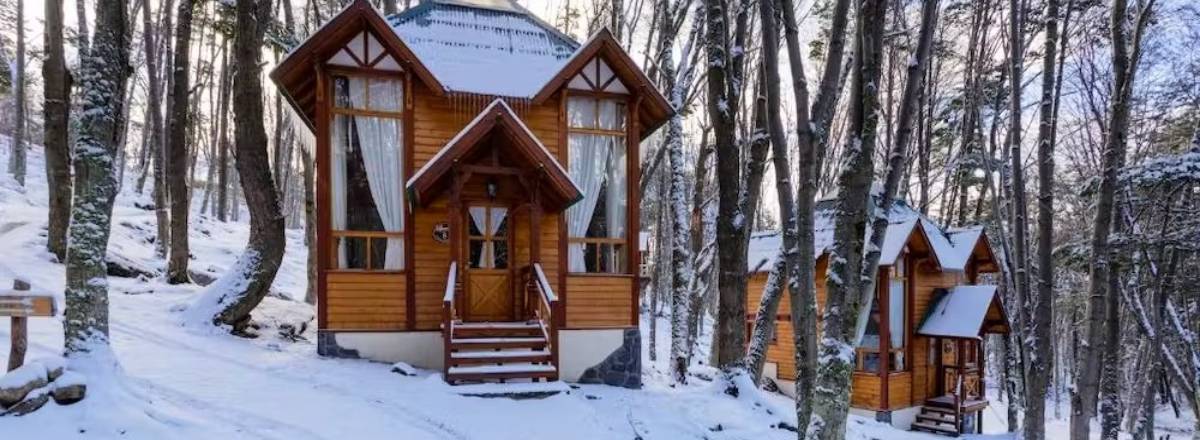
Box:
[445,320,558,385]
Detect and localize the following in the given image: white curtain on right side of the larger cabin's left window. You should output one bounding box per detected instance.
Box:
[349,77,404,270]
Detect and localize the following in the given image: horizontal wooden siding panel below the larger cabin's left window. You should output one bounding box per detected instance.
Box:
[324,272,407,331]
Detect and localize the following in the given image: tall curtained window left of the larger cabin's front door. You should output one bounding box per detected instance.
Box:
[330,76,404,271]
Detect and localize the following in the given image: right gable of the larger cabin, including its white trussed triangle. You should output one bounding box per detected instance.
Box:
[533,28,674,138]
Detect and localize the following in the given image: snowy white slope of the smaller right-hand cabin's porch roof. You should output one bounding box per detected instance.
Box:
[917,285,1007,338]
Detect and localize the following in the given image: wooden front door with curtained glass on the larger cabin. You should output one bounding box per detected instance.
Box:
[463,205,516,321]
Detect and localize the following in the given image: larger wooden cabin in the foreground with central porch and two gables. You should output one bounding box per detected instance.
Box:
[271,0,671,387]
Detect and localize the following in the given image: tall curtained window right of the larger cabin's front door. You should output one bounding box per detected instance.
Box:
[566,96,629,273]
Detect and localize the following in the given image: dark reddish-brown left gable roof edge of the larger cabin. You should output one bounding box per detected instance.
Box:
[270,0,444,129]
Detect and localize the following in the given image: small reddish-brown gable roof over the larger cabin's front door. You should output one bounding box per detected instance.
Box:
[406,98,583,209]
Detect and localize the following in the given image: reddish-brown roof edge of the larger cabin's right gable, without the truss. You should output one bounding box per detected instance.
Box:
[533,28,674,138]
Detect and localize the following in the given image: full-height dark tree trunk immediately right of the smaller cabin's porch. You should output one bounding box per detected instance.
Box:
[1021,0,1058,440]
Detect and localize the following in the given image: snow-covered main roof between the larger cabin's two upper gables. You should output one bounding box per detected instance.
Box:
[388,0,580,98]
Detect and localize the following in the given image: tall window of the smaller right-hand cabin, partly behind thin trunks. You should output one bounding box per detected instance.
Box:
[854,255,908,373]
